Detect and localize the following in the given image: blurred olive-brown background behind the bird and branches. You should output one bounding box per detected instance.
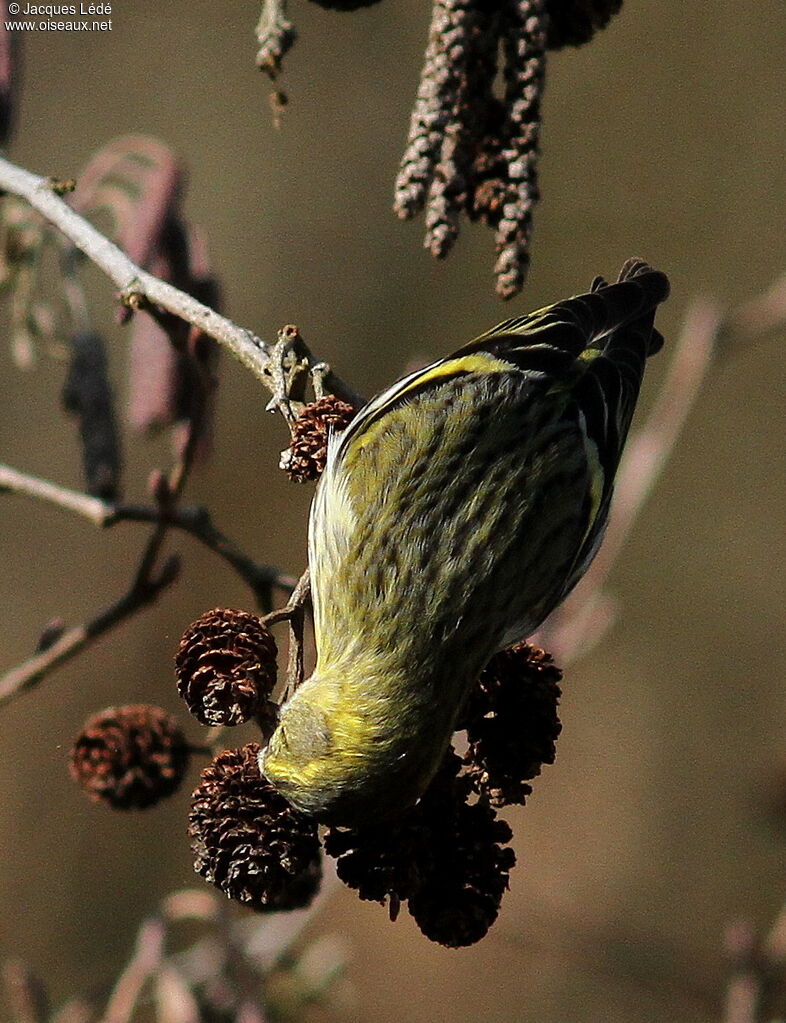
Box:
[0,0,786,1023]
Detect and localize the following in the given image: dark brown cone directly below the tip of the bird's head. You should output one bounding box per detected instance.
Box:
[188,743,321,910]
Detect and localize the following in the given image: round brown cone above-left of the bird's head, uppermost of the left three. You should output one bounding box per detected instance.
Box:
[175,608,277,725]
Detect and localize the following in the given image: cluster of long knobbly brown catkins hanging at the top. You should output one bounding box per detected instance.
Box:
[393,0,621,299]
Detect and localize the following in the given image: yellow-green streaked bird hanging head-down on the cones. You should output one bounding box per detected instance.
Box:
[260,260,668,825]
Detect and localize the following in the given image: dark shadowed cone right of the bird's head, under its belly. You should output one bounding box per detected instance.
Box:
[463,642,562,806]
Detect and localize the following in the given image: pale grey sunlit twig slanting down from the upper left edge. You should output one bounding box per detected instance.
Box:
[0,152,357,403]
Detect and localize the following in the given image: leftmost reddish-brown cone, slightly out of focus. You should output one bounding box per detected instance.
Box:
[71,704,189,810]
